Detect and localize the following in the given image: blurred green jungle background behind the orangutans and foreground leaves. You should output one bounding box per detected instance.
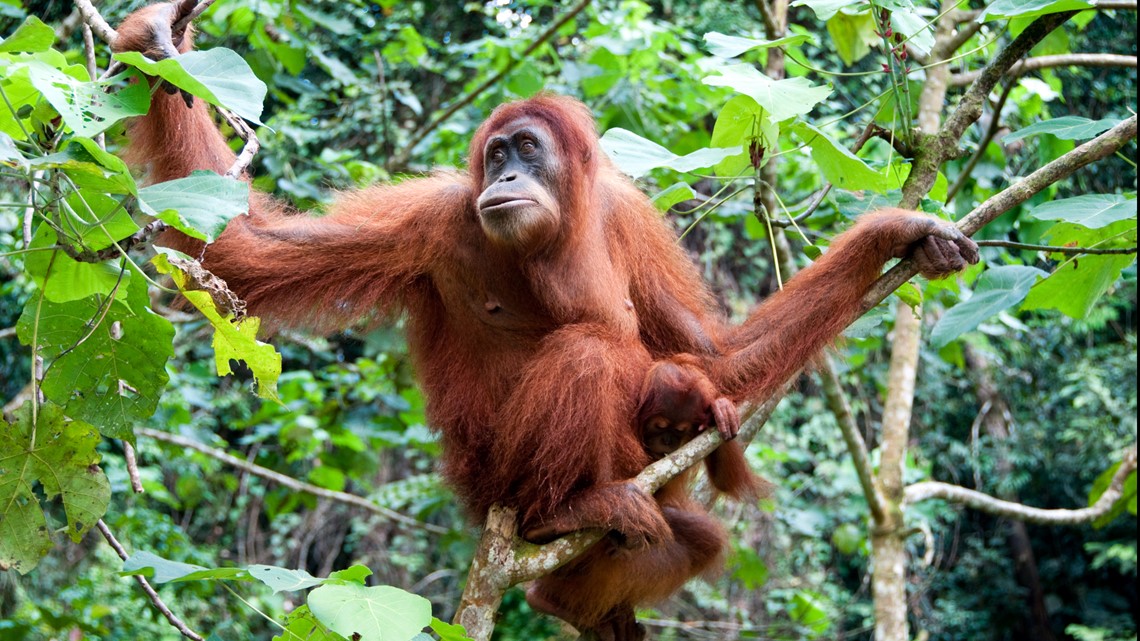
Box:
[0,0,1138,641]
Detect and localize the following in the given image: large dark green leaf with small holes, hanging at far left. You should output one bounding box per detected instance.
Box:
[16,269,174,443]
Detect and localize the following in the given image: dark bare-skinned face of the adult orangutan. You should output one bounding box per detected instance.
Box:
[478,120,561,249]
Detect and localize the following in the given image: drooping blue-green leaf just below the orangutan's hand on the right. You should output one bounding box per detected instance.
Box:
[930,265,1045,349]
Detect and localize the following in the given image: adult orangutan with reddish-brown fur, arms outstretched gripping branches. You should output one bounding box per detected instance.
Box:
[116,5,977,641]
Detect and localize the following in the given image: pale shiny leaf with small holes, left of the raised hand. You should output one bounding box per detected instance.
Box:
[26,60,150,137]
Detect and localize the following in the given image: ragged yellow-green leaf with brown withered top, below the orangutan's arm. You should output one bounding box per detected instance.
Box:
[153,252,282,399]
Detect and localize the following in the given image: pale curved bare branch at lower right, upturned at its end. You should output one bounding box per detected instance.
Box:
[906,445,1137,526]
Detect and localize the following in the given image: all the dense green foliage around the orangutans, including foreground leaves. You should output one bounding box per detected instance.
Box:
[0,0,1138,641]
